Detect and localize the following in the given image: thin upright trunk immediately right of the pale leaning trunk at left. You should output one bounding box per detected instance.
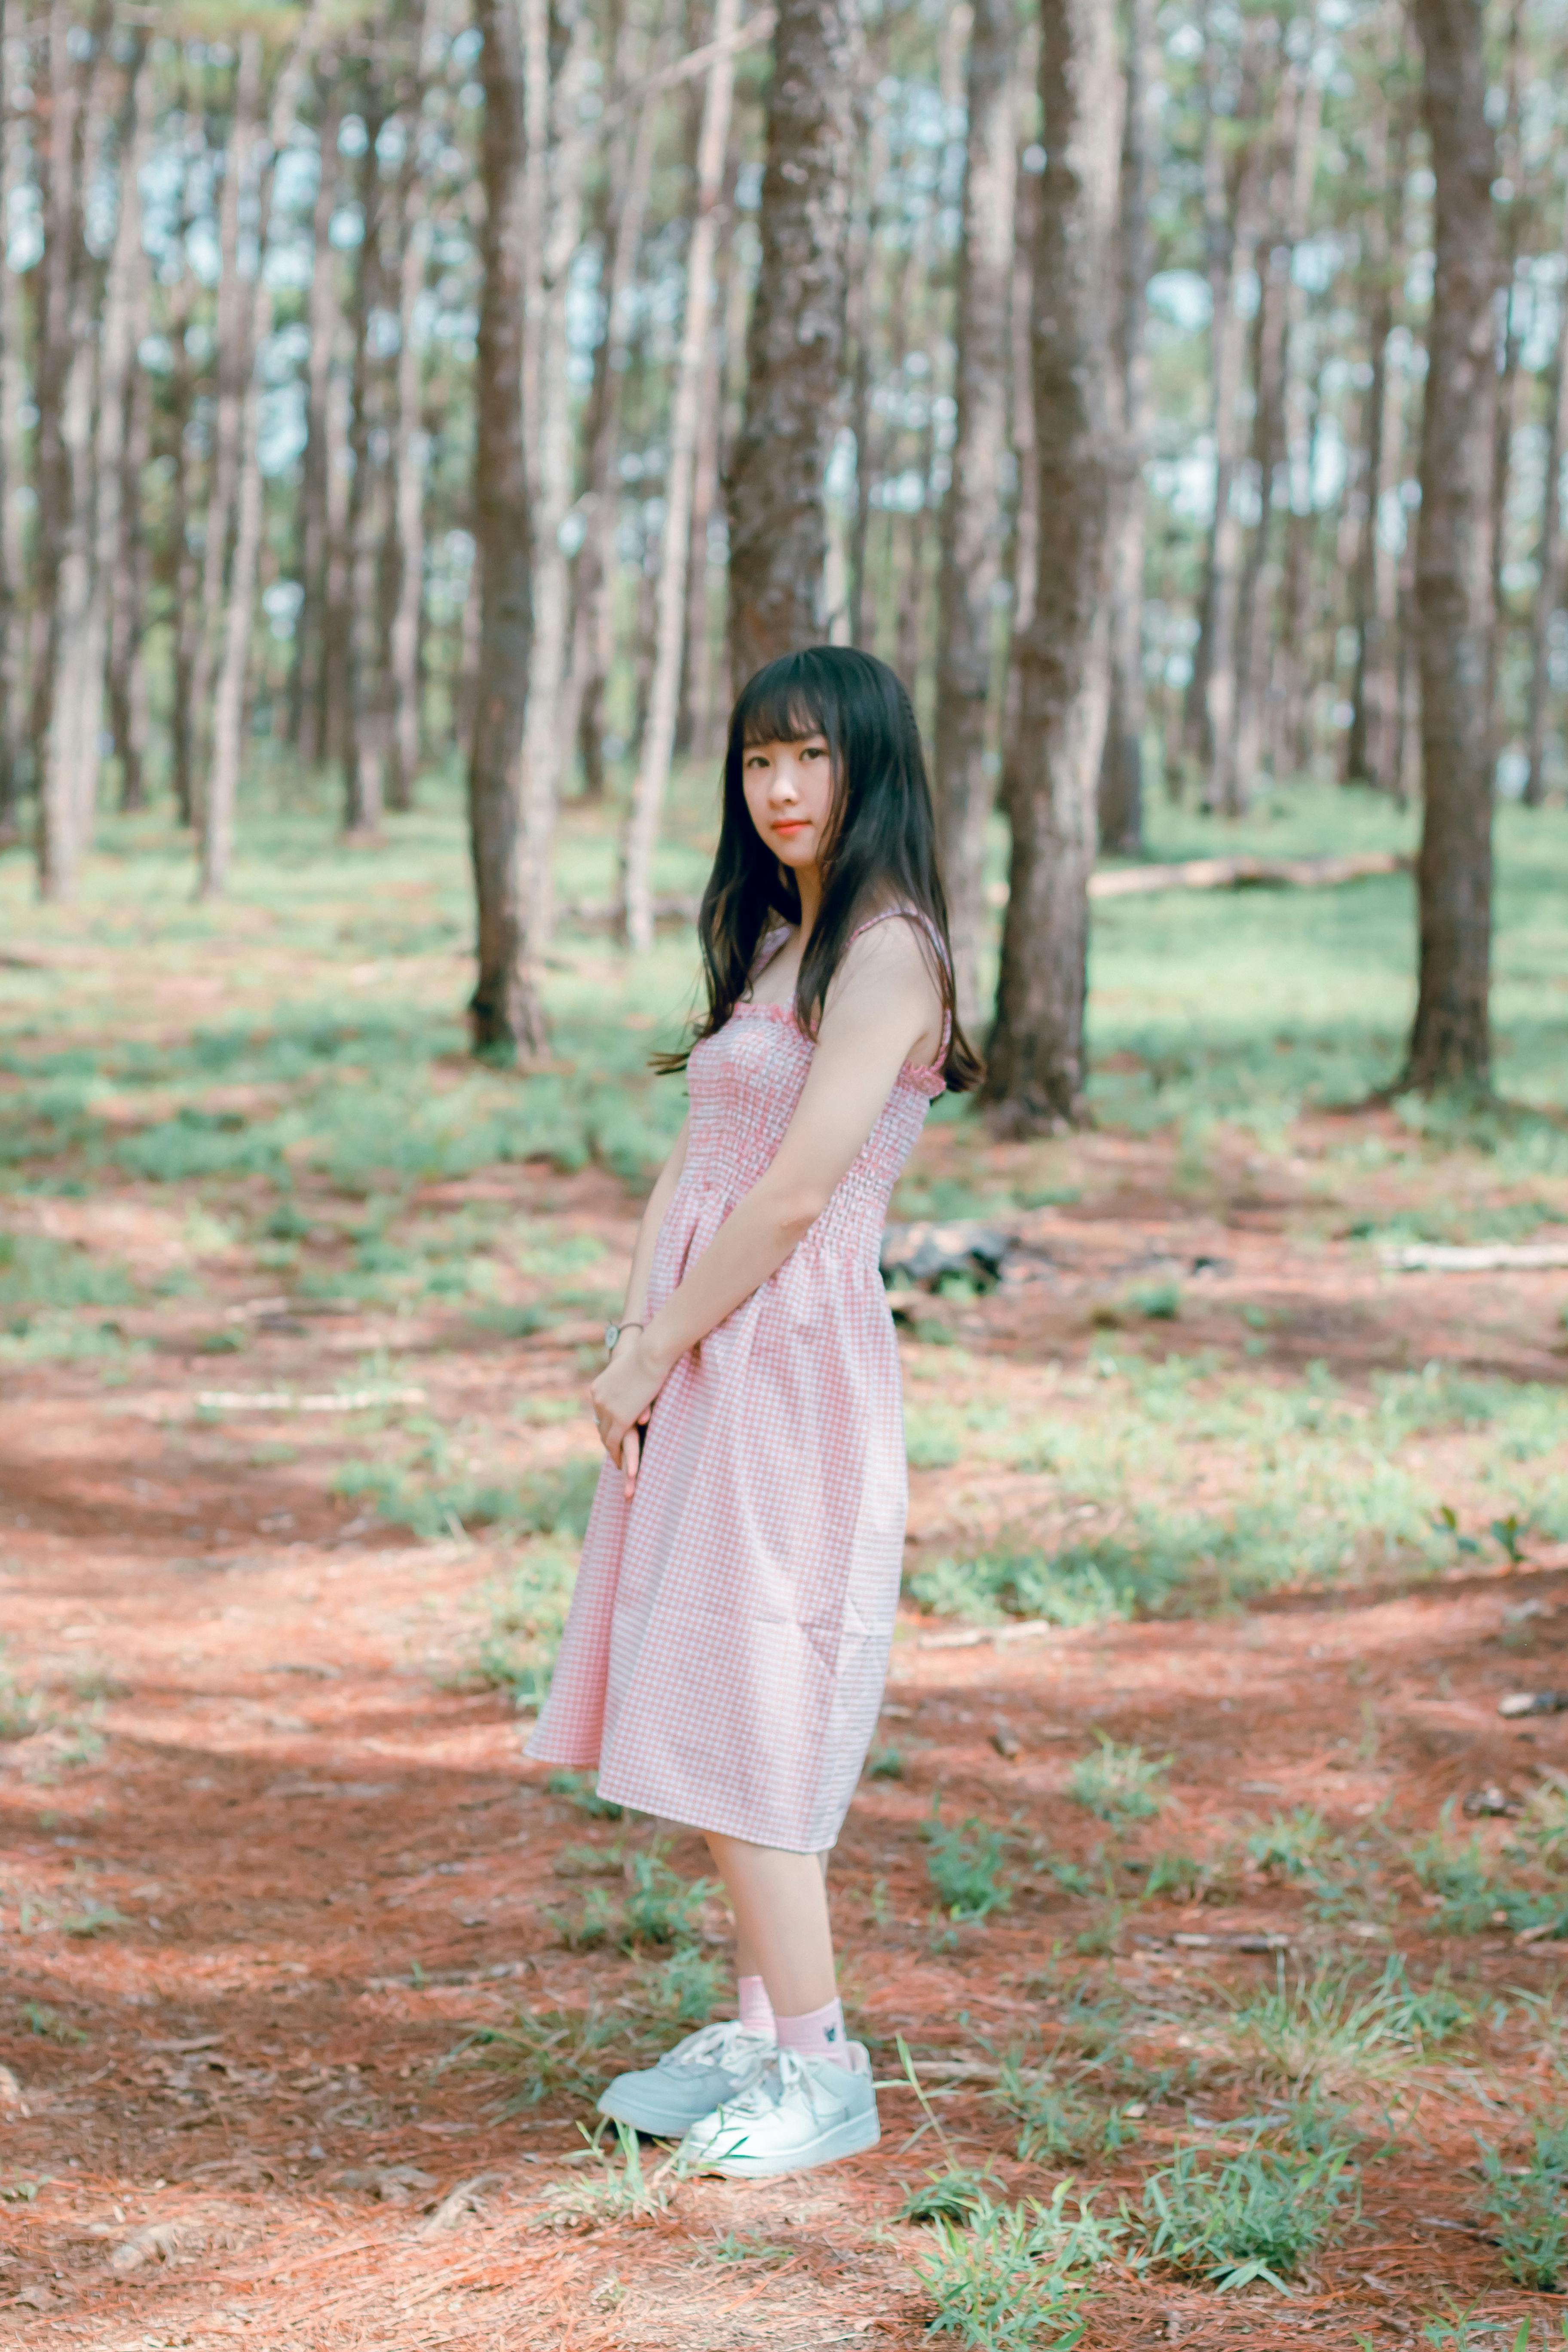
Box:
[289,73,343,767]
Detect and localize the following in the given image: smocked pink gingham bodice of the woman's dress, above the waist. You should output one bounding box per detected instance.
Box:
[670,1004,945,1265]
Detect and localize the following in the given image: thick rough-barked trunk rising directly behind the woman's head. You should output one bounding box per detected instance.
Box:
[729,0,858,684]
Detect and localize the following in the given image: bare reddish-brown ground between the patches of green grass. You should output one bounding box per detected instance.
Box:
[0,1141,1568,2352]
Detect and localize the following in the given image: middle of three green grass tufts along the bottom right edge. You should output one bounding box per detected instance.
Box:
[1142,2147,1354,2293]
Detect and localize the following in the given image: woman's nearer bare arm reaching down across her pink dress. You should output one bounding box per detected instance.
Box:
[592,922,940,1461]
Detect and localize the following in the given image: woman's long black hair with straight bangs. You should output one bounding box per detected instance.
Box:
[656,644,983,1093]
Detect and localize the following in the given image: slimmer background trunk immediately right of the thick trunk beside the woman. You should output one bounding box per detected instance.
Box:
[1100,0,1159,858]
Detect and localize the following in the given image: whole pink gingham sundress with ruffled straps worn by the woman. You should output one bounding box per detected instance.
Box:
[529,908,947,1853]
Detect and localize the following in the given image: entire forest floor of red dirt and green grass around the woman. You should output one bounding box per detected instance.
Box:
[0,781,1568,2352]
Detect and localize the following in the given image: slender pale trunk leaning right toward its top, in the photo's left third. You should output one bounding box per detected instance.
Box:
[197,0,320,898]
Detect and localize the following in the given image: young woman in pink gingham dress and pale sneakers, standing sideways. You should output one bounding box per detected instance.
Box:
[529,647,980,2178]
